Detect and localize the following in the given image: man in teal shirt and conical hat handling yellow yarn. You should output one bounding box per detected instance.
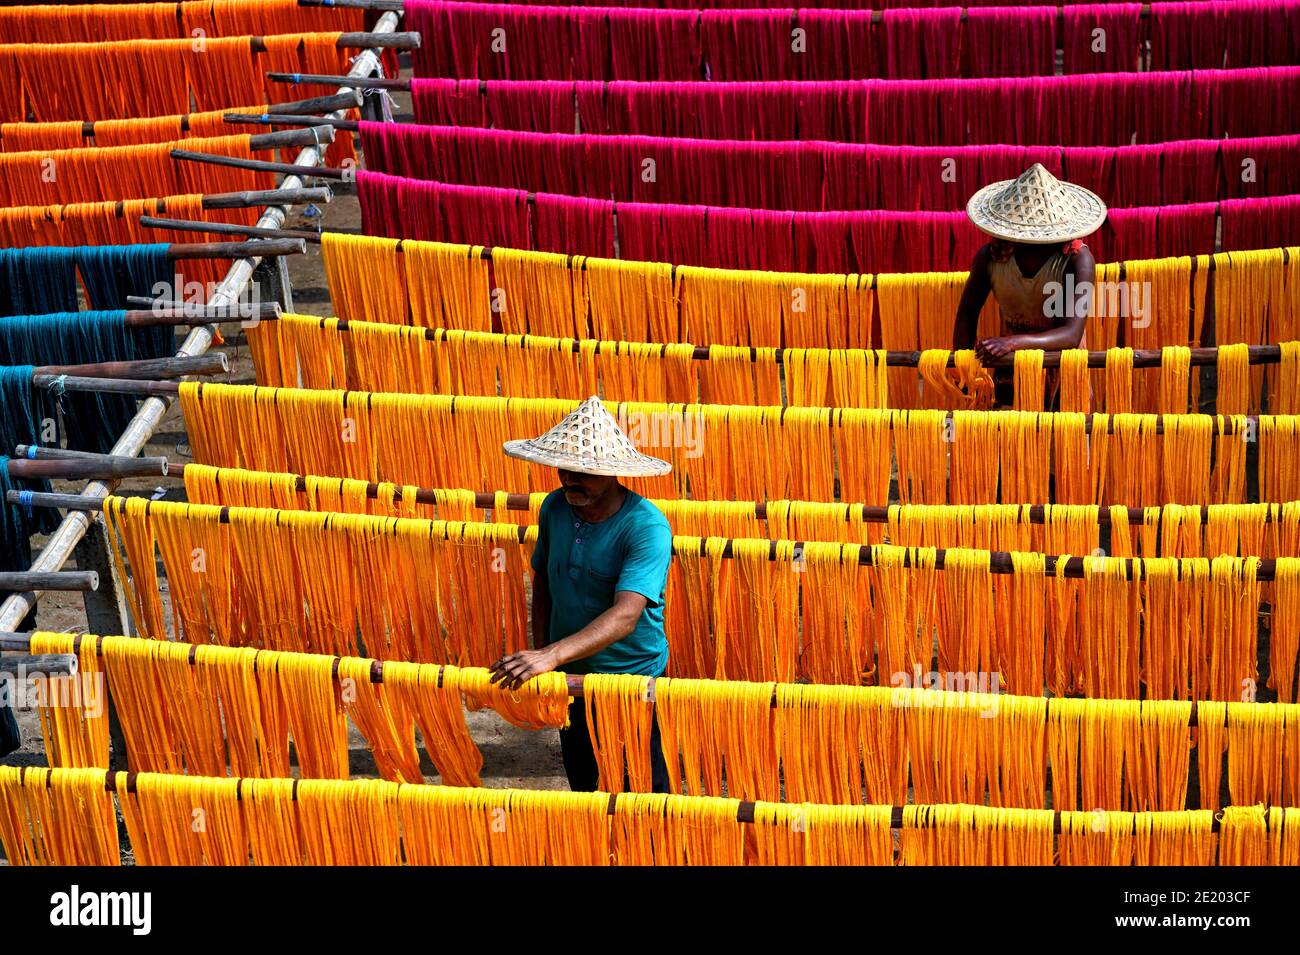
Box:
[493,398,672,793]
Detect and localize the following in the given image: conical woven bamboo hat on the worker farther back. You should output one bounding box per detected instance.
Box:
[966,162,1106,244]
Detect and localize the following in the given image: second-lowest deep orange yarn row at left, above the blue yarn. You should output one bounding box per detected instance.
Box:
[0,135,274,205]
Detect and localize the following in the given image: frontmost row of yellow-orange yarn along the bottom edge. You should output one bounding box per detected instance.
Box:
[10,767,1300,865]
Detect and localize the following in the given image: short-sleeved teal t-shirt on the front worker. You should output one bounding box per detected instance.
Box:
[533,490,672,677]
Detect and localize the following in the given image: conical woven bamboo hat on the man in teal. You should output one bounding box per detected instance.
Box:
[502,395,672,477]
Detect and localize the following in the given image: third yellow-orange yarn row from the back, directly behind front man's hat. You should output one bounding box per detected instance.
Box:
[181,382,1300,507]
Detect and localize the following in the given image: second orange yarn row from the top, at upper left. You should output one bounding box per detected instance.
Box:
[0,32,347,122]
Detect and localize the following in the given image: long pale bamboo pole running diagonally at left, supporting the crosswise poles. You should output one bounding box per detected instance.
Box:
[0,12,400,630]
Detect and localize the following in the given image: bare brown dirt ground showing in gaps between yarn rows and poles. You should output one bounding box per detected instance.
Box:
[0,72,568,789]
